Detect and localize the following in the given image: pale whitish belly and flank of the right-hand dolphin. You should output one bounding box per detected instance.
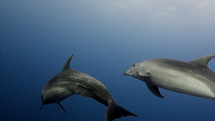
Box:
[151,70,215,99]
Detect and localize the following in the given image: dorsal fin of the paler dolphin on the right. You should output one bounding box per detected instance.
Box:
[190,55,215,68]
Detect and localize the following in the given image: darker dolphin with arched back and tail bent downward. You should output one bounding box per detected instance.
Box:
[41,55,137,121]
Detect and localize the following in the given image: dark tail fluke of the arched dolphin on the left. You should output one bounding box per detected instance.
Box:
[106,104,137,121]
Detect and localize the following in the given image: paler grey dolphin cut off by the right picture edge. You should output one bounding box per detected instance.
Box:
[123,55,215,99]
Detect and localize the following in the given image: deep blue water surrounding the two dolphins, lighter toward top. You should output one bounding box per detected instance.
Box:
[0,0,215,121]
